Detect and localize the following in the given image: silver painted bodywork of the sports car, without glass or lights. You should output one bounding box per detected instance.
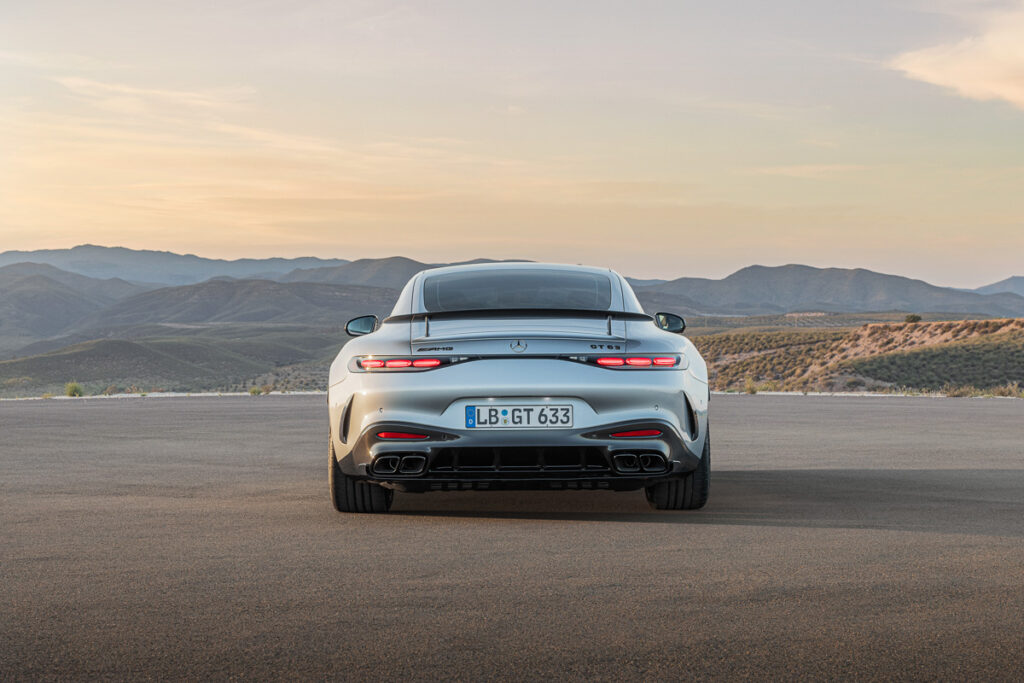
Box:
[328,263,710,476]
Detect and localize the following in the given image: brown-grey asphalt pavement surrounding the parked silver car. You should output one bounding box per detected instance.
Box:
[0,395,1024,680]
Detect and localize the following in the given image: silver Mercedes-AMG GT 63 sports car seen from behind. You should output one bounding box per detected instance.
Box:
[328,263,711,512]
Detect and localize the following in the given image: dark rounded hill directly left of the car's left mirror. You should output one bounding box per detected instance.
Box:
[70,280,398,329]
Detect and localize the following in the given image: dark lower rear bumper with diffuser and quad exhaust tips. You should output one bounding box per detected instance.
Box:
[339,420,699,492]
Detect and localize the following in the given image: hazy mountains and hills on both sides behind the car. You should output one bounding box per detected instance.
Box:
[0,245,1024,395]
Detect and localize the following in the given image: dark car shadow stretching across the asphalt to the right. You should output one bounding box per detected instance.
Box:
[392,469,1024,538]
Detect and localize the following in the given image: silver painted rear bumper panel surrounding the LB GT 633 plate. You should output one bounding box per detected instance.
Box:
[328,357,709,476]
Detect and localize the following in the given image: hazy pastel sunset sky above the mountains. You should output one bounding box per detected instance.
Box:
[0,0,1024,287]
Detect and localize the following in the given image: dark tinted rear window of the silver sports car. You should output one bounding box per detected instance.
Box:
[423,268,611,312]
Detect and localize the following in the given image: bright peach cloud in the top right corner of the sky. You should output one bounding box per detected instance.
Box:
[890,3,1024,110]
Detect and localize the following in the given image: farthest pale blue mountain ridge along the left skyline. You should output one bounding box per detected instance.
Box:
[0,245,347,285]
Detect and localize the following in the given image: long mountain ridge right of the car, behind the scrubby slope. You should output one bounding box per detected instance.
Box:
[641,265,1024,316]
